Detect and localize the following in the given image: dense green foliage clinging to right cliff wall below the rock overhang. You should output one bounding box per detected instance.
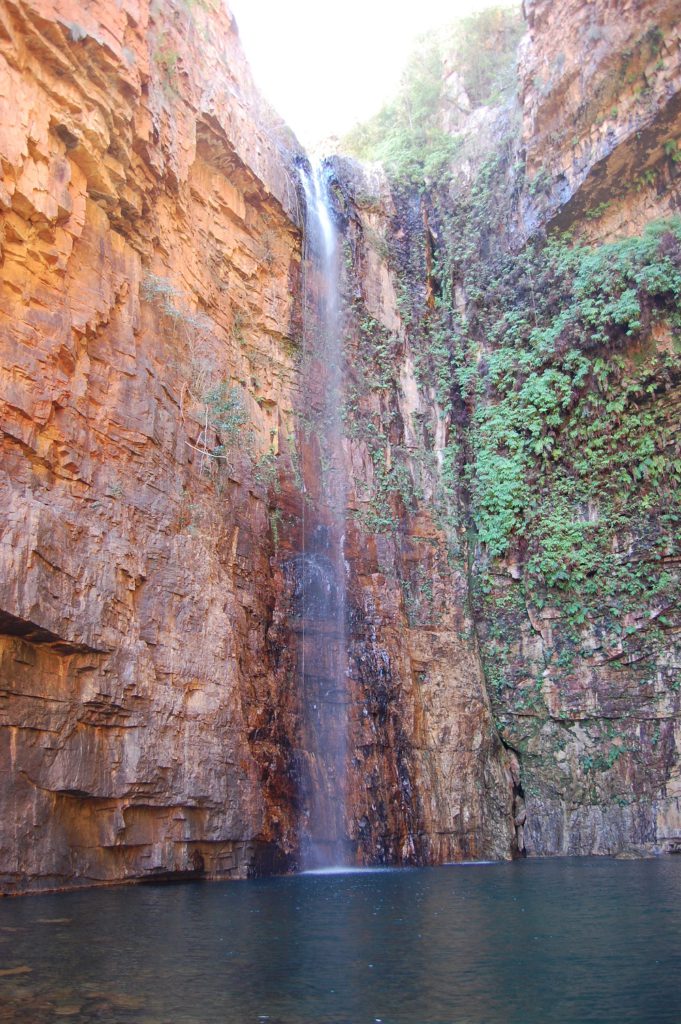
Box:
[473,220,681,668]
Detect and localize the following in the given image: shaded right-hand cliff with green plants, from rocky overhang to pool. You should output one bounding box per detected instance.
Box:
[331,3,681,854]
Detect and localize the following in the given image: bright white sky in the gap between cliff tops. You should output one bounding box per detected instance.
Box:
[227,0,511,146]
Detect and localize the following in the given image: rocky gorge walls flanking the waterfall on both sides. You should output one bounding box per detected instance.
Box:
[0,0,681,892]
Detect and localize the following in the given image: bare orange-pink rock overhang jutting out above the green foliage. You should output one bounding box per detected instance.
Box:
[520,0,681,240]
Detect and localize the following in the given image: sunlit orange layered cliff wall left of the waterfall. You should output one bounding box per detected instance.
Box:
[0,2,300,890]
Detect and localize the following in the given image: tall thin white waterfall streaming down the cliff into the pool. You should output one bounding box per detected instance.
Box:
[294,165,349,869]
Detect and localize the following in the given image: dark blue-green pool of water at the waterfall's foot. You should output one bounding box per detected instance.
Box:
[0,858,681,1024]
